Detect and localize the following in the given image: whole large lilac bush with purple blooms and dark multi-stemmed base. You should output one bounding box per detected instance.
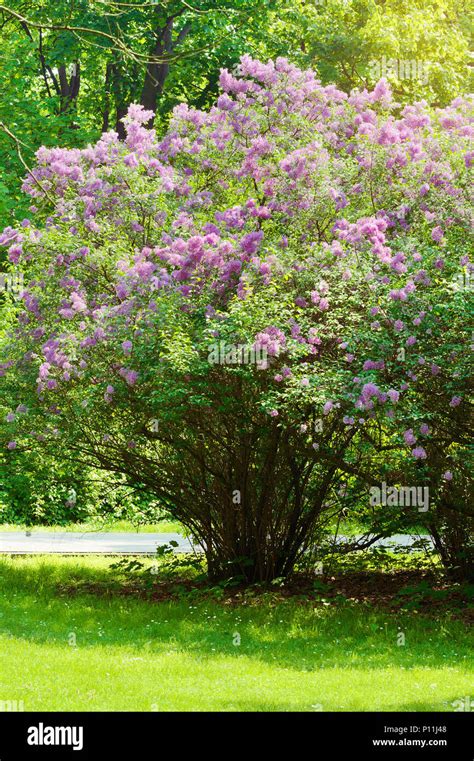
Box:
[0,56,474,580]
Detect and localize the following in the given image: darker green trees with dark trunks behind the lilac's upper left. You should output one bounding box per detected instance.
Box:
[0,0,270,224]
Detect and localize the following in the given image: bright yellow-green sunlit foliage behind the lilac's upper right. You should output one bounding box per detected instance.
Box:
[271,0,472,105]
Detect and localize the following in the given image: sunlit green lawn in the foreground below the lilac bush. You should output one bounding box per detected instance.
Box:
[0,557,474,711]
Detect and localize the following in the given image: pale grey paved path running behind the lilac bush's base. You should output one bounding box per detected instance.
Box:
[0,529,430,555]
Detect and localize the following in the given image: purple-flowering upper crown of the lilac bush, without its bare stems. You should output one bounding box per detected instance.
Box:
[0,56,473,476]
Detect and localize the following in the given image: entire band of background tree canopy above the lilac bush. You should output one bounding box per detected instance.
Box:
[0,0,470,229]
